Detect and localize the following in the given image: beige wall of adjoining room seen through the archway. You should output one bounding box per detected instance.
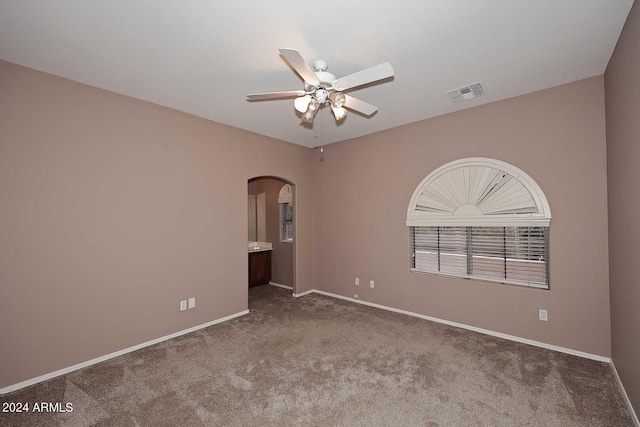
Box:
[257,178,295,286]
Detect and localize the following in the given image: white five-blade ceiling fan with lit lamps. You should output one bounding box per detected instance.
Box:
[247,49,393,123]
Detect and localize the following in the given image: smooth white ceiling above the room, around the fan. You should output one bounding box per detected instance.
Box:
[0,0,633,147]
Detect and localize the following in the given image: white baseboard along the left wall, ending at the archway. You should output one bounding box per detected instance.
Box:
[0,310,249,394]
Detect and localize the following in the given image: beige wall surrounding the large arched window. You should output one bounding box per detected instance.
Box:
[313,77,610,356]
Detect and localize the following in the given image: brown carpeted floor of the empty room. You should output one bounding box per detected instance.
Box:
[0,285,633,427]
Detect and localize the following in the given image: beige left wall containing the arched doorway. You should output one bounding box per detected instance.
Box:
[0,62,313,388]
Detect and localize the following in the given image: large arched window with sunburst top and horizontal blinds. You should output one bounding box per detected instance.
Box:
[407,158,551,289]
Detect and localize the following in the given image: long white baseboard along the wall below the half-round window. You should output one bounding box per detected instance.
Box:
[302,289,611,363]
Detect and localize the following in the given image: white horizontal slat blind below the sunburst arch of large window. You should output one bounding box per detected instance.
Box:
[411,226,549,289]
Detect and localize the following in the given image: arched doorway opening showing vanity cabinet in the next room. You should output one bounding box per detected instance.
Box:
[247,176,297,293]
